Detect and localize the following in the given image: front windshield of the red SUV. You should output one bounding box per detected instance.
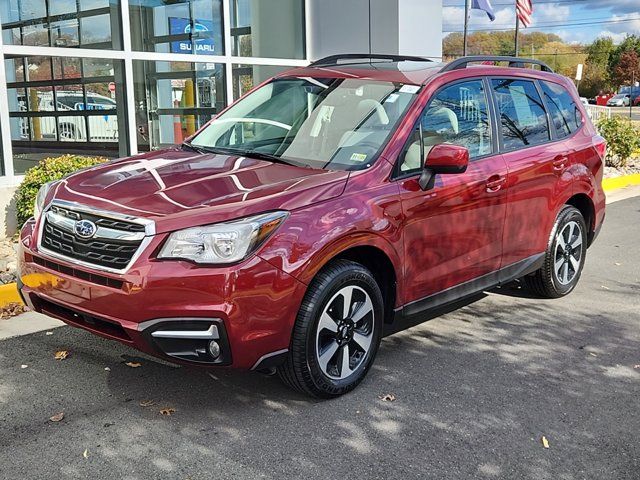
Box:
[191,77,419,170]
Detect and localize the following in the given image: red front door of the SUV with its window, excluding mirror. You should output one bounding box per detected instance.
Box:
[397,79,507,304]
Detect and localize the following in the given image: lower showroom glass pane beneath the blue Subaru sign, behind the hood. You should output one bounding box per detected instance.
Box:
[133,61,225,150]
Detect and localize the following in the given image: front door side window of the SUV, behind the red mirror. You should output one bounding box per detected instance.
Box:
[400,80,492,172]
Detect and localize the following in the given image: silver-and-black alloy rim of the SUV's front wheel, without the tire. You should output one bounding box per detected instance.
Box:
[316,285,374,380]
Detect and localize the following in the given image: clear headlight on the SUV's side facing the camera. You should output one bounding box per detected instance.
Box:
[158,212,288,264]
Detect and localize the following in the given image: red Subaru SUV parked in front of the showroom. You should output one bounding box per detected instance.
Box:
[20,55,605,397]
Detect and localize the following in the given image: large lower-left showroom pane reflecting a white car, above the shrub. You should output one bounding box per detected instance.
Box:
[6,57,129,174]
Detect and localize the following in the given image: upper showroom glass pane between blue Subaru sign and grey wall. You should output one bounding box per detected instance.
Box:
[230,0,305,59]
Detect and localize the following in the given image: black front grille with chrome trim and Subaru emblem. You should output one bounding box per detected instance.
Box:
[41,205,145,270]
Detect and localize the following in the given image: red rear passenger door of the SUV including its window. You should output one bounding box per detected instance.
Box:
[491,78,571,272]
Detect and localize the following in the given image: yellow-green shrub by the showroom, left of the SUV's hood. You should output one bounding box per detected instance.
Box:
[16,155,107,225]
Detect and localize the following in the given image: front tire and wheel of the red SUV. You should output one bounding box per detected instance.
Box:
[278,260,384,398]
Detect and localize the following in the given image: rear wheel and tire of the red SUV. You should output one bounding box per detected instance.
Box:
[524,205,587,298]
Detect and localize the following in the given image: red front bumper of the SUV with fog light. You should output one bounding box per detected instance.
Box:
[18,222,306,369]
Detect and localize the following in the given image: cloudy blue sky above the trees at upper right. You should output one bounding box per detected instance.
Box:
[443,0,640,43]
